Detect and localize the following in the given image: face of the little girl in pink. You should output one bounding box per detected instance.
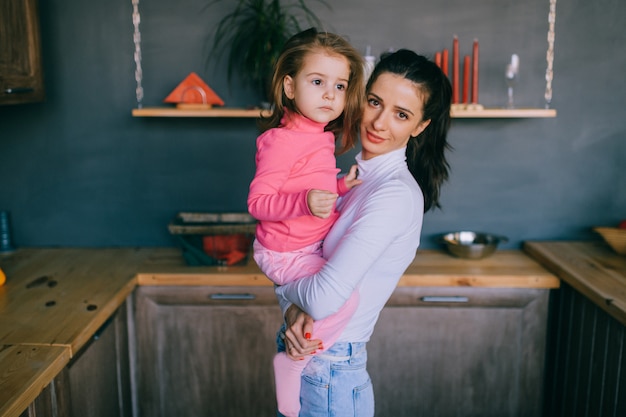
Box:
[283,50,350,123]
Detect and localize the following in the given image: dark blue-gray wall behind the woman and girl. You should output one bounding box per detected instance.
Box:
[0,0,626,247]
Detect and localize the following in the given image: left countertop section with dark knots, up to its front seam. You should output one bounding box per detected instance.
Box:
[0,248,154,356]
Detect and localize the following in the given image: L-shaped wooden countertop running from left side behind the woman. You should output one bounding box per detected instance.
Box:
[0,248,559,417]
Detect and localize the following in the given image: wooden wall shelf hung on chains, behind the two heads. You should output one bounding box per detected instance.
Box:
[132,106,556,119]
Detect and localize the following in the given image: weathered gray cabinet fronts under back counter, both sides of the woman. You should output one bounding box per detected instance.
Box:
[135,286,549,417]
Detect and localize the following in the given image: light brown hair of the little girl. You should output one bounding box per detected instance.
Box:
[259,28,365,154]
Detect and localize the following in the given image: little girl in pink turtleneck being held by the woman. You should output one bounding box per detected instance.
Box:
[248,28,364,417]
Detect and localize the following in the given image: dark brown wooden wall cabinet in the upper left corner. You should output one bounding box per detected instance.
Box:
[0,0,44,104]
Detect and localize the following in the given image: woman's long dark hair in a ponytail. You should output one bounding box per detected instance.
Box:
[366,49,452,212]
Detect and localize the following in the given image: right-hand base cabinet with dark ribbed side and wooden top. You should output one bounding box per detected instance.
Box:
[524,240,626,417]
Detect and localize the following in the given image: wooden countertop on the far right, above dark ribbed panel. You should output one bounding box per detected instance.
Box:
[524,241,626,326]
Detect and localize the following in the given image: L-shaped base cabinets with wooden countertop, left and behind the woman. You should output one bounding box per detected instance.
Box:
[0,248,559,417]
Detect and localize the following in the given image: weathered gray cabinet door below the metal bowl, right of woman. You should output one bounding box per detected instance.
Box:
[368,287,549,417]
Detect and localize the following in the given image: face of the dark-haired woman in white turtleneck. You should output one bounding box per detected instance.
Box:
[361,73,430,159]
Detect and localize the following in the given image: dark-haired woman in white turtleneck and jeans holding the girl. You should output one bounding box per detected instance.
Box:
[276,50,452,417]
